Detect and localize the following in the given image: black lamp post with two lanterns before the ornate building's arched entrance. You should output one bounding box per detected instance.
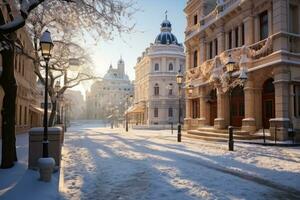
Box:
[225,55,248,151]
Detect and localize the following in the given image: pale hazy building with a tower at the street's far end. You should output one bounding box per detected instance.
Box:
[86,58,133,120]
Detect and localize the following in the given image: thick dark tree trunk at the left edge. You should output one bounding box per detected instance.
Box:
[0,38,17,168]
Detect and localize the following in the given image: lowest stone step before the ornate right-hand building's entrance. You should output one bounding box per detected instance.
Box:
[187,130,262,140]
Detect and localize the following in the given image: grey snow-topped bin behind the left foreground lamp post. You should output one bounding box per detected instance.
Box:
[28,127,62,170]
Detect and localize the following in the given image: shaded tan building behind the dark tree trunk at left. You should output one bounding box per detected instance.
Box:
[0,1,43,135]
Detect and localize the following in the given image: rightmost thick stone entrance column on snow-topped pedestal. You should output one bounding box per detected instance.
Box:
[270,66,290,140]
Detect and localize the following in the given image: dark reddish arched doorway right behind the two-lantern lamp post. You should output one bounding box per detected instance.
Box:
[230,86,245,127]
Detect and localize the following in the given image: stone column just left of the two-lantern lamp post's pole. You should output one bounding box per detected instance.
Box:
[214,87,226,129]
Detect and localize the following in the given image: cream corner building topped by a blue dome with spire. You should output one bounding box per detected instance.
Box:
[128,17,185,127]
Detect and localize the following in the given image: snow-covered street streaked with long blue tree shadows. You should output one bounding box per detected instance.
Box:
[60,123,300,200]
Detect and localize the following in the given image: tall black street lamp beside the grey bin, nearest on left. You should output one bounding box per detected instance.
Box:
[40,30,54,158]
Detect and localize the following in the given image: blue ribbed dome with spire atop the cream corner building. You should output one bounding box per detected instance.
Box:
[154,15,180,45]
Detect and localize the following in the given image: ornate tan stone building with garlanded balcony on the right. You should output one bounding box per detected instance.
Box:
[185,0,300,140]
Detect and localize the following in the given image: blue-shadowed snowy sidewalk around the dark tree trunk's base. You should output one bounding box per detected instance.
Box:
[0,133,59,200]
